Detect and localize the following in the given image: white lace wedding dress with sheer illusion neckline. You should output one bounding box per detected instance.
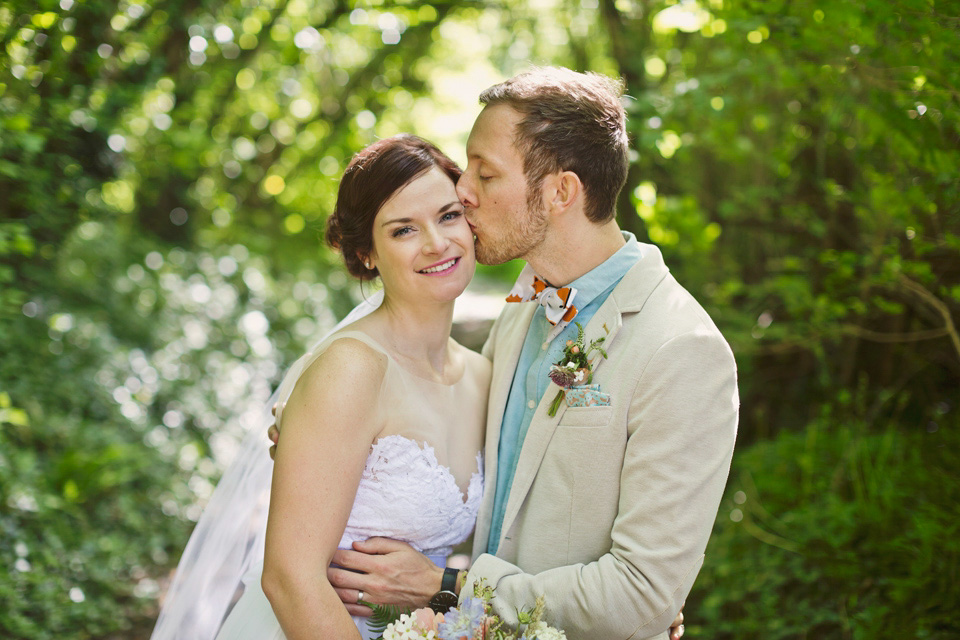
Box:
[217,331,490,640]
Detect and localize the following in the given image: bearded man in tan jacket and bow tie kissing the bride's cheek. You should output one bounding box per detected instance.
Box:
[274,68,738,640]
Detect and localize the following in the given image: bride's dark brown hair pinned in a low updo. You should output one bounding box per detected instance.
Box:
[326,133,461,280]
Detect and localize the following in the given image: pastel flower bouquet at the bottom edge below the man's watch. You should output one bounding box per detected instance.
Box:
[374,580,567,640]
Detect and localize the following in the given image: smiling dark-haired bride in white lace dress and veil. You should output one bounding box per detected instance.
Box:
[152,135,490,640]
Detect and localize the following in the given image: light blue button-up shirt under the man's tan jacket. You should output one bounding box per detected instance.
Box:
[487,232,643,554]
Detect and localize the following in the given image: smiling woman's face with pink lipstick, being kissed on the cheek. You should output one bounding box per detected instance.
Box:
[370,167,475,302]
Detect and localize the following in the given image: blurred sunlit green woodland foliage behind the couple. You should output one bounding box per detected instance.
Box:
[0,0,960,639]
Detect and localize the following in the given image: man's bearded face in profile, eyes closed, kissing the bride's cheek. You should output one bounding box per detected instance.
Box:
[457,104,547,264]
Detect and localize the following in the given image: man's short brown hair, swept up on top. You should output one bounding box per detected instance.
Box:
[480,67,629,222]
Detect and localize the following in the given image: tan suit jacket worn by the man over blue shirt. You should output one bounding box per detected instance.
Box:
[462,245,739,640]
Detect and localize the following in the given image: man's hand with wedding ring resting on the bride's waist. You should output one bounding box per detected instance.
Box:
[327,538,443,616]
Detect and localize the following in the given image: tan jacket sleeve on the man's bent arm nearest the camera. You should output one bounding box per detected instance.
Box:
[466,325,739,640]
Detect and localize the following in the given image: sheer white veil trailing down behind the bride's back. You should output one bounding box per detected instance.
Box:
[150,291,383,640]
